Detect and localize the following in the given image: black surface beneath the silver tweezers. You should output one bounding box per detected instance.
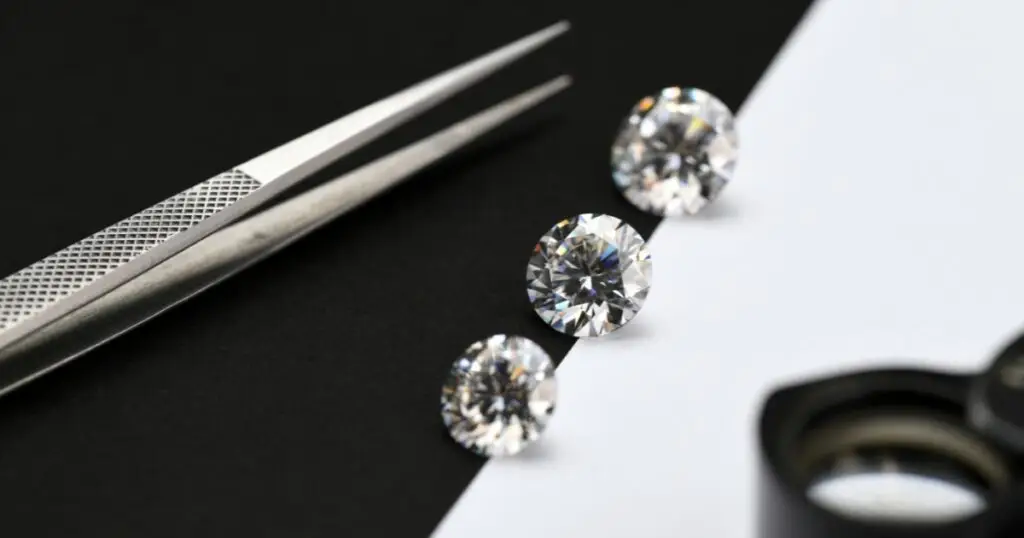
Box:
[0,0,807,538]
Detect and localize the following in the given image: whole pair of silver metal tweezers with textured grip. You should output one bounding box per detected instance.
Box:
[0,22,570,394]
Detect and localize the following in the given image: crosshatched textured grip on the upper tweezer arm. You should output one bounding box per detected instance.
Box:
[0,170,262,333]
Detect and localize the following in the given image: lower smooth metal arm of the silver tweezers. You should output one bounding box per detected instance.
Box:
[0,77,570,395]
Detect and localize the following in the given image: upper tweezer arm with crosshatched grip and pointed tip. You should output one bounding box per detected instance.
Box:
[0,23,568,354]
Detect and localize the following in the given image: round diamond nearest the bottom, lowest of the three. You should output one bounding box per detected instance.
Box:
[441,334,557,456]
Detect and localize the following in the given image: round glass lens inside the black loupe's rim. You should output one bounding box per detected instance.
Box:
[800,410,1010,524]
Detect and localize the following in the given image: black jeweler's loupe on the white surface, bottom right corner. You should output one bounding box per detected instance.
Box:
[758,336,1024,538]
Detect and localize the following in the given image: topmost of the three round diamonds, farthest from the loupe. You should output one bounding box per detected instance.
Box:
[611,87,738,216]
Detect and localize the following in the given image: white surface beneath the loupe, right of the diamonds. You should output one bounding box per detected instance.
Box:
[436,0,1024,538]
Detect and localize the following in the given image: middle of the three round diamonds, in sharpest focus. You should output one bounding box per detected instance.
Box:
[526,213,651,336]
